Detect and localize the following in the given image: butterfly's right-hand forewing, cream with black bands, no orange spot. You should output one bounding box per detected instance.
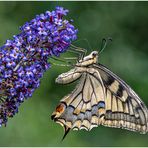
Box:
[94,64,148,133]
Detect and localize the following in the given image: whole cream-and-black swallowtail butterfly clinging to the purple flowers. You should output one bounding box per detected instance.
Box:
[51,51,148,137]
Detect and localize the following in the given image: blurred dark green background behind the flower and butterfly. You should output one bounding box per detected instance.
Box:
[0,1,148,147]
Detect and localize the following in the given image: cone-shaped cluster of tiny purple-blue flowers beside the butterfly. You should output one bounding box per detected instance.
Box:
[0,7,77,126]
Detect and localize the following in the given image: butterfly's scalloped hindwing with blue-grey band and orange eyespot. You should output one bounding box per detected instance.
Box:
[52,73,105,130]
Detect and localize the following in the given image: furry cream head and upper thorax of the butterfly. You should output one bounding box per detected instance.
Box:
[76,51,99,66]
